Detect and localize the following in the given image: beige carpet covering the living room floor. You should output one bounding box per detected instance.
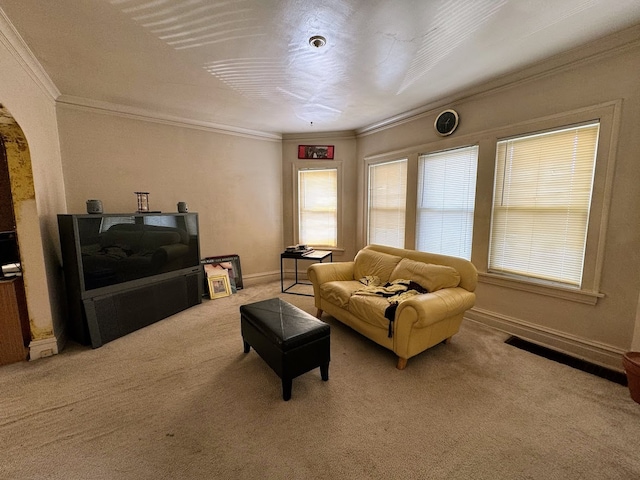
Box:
[0,283,640,480]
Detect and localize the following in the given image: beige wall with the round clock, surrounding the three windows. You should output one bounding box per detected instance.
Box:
[358,28,640,369]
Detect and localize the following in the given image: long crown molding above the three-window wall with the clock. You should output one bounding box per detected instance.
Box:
[356,25,640,137]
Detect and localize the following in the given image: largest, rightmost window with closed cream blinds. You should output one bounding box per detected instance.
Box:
[489,123,599,287]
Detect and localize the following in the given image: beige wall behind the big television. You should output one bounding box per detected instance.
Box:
[58,105,283,279]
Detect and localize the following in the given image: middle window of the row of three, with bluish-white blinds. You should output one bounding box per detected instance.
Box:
[416,146,478,260]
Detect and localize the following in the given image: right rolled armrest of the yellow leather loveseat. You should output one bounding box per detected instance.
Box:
[396,287,476,329]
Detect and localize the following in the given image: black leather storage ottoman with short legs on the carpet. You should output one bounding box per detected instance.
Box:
[240,298,330,401]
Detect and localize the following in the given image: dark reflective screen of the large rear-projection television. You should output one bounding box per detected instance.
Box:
[77,214,200,290]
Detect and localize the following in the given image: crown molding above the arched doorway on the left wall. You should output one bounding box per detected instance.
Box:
[0,8,60,101]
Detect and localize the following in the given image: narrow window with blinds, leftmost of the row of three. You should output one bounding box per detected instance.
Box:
[368,159,407,248]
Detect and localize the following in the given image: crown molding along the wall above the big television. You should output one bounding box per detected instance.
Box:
[56,95,282,142]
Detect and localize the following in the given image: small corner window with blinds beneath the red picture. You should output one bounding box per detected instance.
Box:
[298,168,338,247]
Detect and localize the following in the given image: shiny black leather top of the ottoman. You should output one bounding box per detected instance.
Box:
[240,298,330,351]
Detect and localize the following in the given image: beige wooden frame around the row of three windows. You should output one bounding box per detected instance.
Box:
[358,99,622,305]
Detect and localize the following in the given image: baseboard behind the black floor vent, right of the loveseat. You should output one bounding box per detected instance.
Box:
[465,308,625,372]
